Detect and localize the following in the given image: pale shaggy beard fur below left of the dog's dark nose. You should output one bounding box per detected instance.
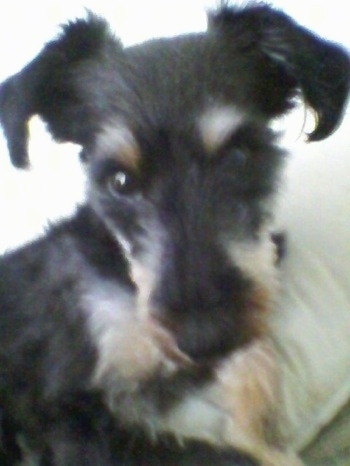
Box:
[86,315,211,430]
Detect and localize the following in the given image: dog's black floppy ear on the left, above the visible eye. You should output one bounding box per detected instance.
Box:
[0,13,123,167]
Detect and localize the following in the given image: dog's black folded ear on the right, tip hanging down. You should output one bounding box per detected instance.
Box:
[209,4,350,141]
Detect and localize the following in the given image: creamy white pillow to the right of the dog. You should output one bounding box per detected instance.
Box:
[271,117,350,450]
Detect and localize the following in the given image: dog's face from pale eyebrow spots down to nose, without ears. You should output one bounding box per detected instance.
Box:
[87,109,281,360]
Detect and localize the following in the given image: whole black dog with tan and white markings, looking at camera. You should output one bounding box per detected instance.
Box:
[0,3,350,466]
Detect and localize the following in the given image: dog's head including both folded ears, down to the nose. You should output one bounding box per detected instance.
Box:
[0,4,350,368]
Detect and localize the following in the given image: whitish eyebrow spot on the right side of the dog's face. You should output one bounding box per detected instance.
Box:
[199,105,245,154]
